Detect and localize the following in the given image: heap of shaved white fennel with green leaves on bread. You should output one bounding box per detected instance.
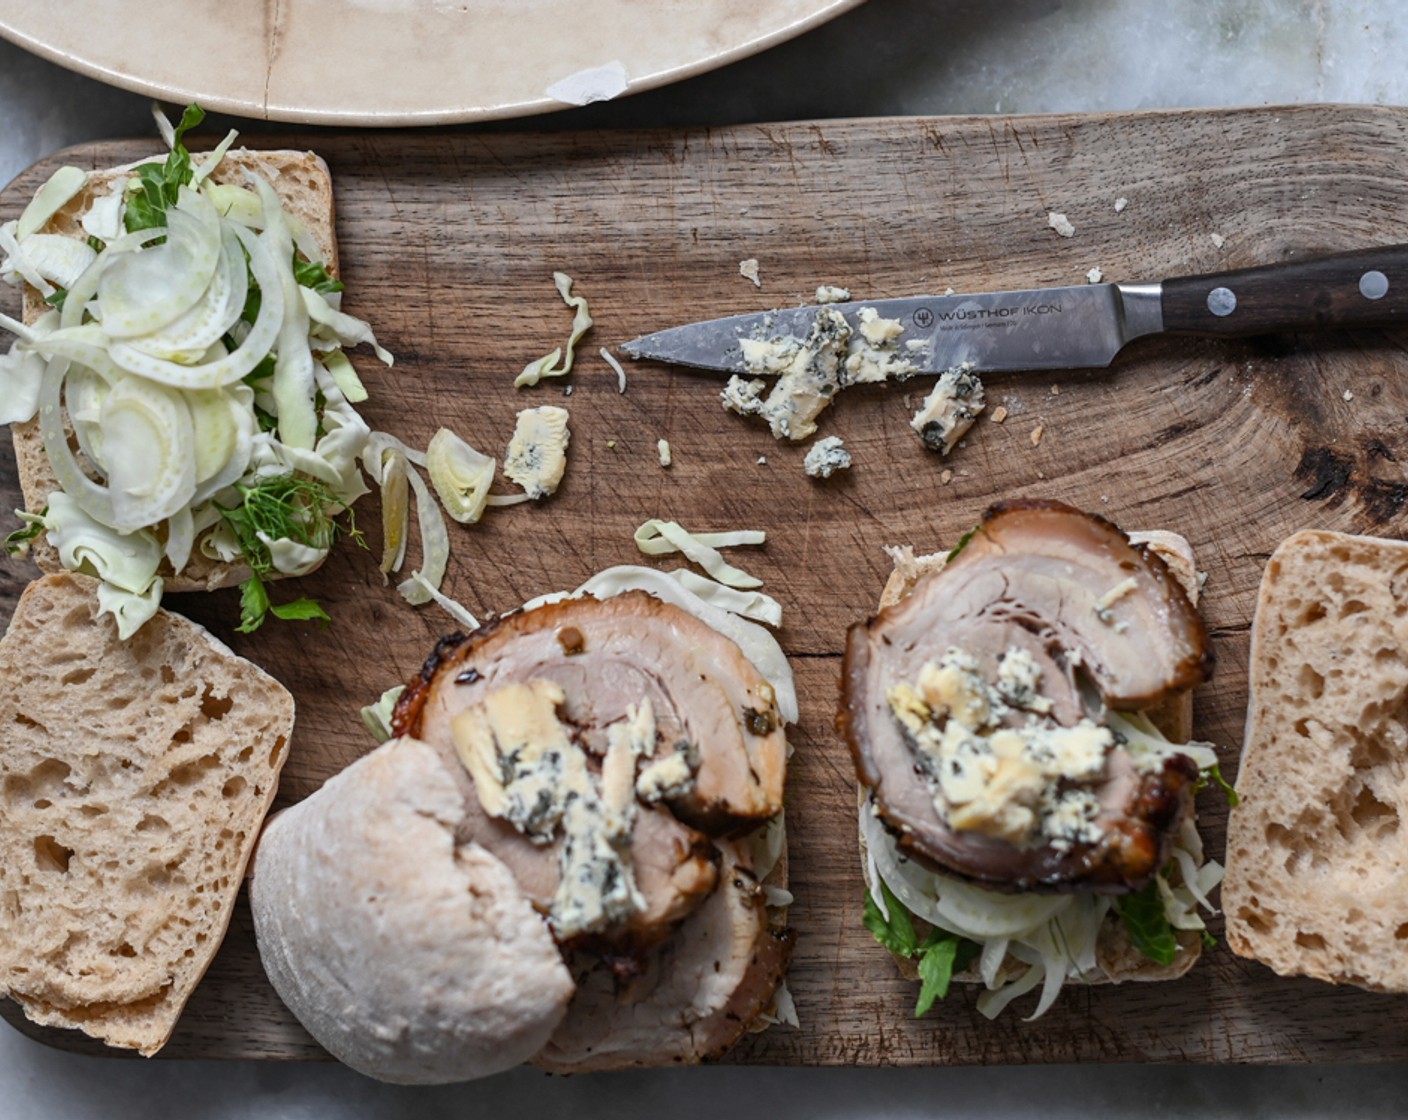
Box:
[0,106,391,637]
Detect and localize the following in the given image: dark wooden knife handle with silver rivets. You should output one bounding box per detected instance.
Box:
[1163,245,1408,335]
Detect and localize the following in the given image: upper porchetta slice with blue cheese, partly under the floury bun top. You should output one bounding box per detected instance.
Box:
[393,592,787,947]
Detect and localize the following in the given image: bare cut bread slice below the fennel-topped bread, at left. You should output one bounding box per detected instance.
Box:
[0,573,293,1054]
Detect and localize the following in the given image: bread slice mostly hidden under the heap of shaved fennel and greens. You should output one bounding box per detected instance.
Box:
[11,148,338,592]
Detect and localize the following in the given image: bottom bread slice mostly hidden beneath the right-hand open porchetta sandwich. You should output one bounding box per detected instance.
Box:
[856,530,1202,983]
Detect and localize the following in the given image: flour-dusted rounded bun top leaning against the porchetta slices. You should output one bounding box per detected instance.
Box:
[249,738,573,1083]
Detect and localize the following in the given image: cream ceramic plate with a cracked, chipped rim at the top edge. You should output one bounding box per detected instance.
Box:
[0,0,860,125]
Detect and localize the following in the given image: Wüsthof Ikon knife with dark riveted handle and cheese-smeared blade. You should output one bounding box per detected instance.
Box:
[621,245,1408,373]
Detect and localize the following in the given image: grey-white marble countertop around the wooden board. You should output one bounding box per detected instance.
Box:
[0,0,1408,1120]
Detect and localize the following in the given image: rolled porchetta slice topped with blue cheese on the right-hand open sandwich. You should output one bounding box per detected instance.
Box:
[838,502,1211,892]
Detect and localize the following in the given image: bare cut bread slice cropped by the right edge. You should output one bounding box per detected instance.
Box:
[1222,530,1408,992]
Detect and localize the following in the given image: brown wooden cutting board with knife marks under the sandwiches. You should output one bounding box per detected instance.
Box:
[0,107,1408,1065]
